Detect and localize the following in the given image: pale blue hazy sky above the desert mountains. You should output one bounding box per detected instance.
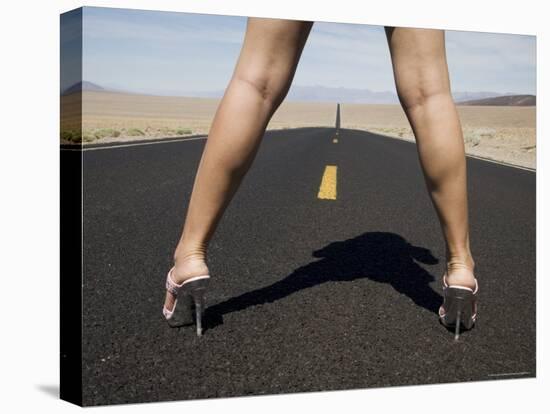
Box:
[75,7,536,94]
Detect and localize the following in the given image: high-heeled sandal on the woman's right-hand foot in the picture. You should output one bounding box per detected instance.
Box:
[439,272,478,341]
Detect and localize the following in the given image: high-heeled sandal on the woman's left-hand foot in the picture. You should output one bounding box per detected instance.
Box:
[162,267,210,336]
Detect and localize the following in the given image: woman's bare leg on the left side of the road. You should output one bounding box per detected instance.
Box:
[166,18,313,309]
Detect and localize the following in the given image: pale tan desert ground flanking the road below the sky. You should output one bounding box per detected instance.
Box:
[61,91,536,168]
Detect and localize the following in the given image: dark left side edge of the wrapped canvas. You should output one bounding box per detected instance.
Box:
[59,8,83,406]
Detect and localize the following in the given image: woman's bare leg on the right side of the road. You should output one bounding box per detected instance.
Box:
[386,27,475,288]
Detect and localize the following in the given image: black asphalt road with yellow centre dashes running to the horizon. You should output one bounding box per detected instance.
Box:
[78,124,536,405]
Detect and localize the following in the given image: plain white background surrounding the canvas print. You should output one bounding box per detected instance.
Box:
[0,0,550,414]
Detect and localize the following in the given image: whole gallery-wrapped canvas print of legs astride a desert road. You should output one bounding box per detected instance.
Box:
[60,7,536,406]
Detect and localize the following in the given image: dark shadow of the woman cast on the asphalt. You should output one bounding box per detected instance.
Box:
[205,232,442,328]
